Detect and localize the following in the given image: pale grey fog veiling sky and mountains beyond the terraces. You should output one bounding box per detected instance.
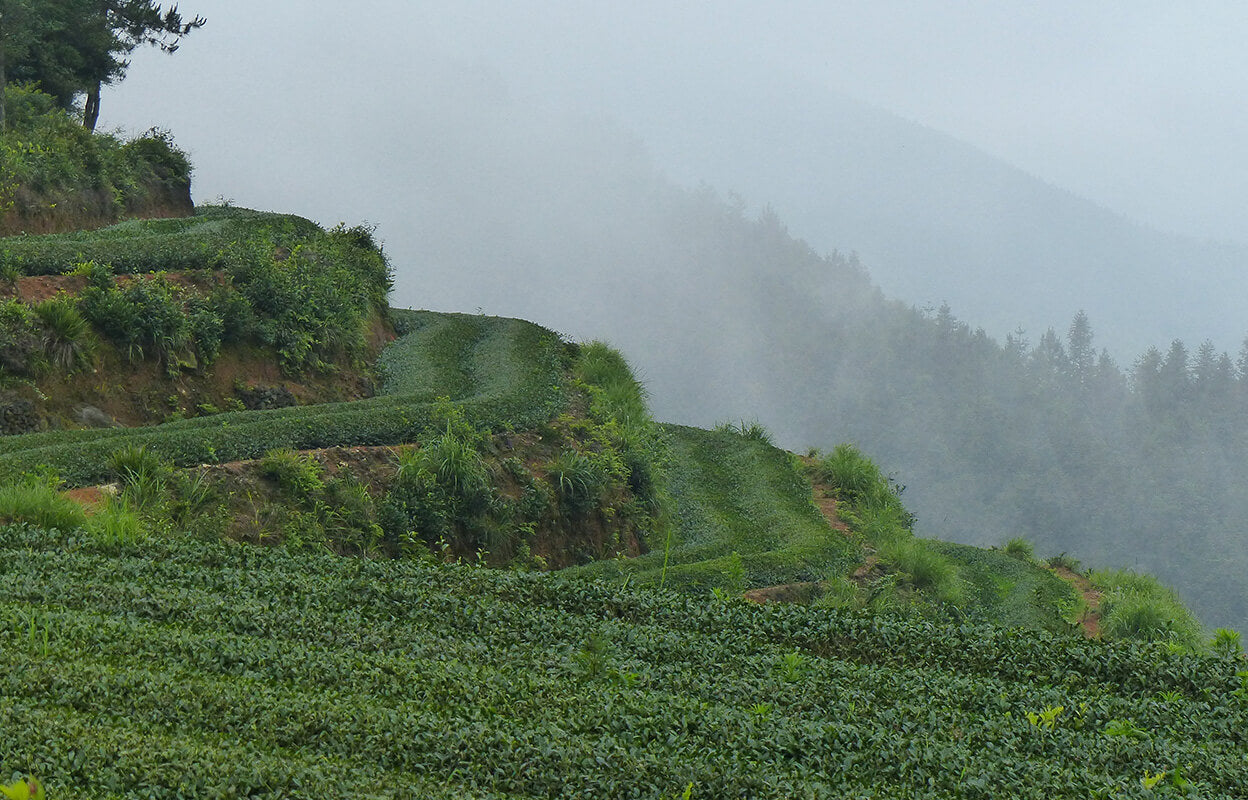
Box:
[101,0,1248,624]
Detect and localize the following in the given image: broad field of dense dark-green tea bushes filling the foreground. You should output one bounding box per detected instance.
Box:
[0,527,1248,799]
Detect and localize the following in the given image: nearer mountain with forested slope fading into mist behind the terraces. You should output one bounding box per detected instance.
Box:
[362,68,1248,627]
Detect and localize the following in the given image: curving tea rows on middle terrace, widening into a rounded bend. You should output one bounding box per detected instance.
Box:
[0,313,567,485]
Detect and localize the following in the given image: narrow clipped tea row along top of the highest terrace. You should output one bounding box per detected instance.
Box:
[0,206,321,275]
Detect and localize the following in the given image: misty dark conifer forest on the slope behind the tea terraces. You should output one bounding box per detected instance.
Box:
[633,192,1248,628]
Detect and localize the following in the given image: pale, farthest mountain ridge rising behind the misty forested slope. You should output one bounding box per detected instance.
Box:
[628,77,1248,358]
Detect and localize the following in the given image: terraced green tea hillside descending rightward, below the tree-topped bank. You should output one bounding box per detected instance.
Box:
[0,115,1233,799]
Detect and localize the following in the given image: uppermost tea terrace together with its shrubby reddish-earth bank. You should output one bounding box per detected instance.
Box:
[0,207,393,433]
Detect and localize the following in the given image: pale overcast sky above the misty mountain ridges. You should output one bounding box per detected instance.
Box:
[102,0,1248,246]
